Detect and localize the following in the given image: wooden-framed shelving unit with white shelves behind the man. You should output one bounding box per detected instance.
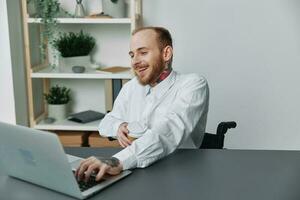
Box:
[21,0,143,128]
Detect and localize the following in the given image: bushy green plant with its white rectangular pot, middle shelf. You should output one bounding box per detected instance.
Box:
[53,30,96,69]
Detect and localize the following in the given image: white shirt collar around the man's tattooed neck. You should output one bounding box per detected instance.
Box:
[146,70,176,99]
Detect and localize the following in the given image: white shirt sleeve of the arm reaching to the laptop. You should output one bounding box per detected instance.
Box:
[113,76,209,170]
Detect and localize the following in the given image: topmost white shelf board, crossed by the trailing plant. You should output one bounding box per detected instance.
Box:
[27,18,131,24]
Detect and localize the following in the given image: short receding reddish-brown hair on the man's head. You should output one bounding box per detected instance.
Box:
[132,26,173,50]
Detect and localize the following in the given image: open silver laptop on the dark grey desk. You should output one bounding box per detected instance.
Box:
[0,122,131,199]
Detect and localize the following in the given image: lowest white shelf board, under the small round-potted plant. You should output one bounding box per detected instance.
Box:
[33,119,101,131]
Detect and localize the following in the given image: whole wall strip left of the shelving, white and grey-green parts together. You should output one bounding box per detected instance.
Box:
[0,0,28,125]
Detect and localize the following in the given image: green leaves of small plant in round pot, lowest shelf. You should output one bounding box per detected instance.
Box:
[44,85,71,105]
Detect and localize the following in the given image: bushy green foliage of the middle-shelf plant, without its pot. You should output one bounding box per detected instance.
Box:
[53,30,96,57]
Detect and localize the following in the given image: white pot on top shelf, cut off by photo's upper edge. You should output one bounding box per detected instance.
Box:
[102,0,126,18]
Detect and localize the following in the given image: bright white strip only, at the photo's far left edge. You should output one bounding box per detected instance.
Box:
[0,0,16,124]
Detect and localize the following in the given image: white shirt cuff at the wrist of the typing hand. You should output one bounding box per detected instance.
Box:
[112,146,137,170]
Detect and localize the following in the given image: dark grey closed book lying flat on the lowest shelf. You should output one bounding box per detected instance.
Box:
[68,110,105,123]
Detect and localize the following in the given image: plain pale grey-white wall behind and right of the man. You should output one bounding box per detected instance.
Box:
[143,0,300,149]
